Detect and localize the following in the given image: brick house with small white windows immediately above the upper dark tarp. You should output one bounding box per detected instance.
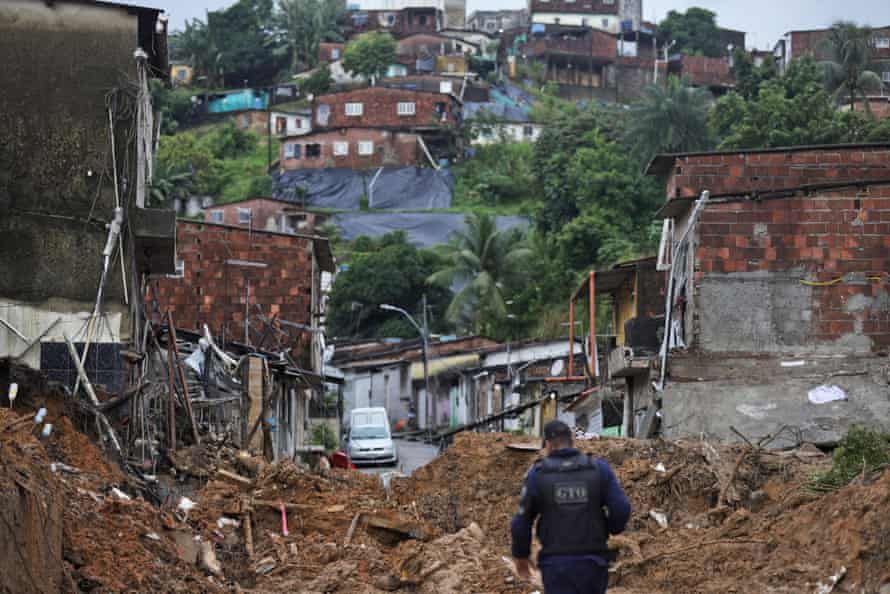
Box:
[280,128,424,170]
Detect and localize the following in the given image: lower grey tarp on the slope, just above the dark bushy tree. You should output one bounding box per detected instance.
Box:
[332,212,529,247]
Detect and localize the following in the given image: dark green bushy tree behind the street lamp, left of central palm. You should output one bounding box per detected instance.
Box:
[328,232,451,338]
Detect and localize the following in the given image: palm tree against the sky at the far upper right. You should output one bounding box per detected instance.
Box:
[820,21,881,109]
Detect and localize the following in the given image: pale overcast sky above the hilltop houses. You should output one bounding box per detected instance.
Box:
[151,0,890,49]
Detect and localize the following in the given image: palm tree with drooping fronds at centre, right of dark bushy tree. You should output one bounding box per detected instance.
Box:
[428,214,530,334]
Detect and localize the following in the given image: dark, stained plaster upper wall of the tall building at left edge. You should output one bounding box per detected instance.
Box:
[0,0,138,302]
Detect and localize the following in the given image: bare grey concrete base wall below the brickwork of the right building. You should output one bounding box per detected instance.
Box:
[662,356,890,447]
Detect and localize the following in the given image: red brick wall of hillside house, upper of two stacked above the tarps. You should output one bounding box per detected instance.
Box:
[312,87,458,128]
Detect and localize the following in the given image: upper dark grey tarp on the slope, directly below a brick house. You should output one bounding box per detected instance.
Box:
[272,167,454,210]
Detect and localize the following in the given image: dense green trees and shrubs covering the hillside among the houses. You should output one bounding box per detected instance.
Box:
[160,9,890,340]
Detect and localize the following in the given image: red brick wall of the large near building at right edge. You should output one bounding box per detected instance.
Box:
[695,185,890,351]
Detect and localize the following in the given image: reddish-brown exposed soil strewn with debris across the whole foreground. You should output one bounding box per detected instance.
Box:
[0,380,890,594]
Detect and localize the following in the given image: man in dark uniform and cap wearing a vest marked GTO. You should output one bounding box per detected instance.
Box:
[510,421,630,594]
